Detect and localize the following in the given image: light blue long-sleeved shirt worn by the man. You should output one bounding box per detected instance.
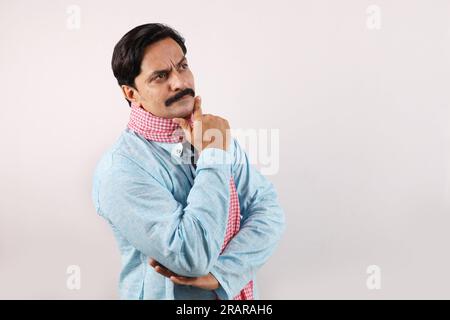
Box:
[92,128,285,300]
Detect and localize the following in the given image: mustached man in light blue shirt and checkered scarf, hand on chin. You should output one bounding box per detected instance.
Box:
[92,24,285,300]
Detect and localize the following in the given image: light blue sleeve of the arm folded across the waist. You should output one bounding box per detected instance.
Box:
[211,140,285,300]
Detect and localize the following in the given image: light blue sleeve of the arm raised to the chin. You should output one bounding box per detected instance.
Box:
[94,148,231,277]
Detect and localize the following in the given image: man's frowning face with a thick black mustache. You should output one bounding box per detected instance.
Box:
[122,38,195,118]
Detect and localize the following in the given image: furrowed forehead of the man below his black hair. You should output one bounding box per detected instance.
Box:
[141,38,184,73]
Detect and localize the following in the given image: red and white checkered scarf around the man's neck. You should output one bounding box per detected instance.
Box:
[128,104,254,300]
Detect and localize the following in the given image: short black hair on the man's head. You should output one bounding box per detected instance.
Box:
[111,23,187,106]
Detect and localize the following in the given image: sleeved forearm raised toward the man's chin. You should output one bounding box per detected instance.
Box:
[149,149,231,277]
